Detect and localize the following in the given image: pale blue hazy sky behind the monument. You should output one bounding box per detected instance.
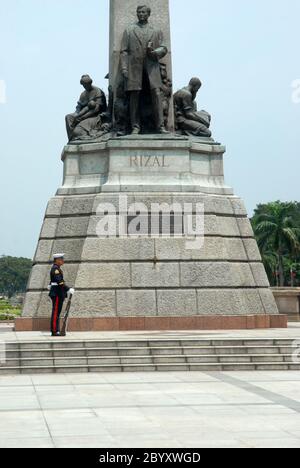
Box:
[0,0,300,257]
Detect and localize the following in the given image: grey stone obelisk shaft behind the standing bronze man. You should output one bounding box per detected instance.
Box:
[109,0,174,129]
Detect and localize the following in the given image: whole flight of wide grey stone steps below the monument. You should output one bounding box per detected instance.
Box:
[0,338,300,375]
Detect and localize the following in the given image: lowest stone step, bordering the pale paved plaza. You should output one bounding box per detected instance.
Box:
[0,362,300,375]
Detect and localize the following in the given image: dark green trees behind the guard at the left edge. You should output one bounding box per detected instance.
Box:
[0,256,32,297]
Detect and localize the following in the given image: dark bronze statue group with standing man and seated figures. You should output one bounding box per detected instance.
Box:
[66,6,211,142]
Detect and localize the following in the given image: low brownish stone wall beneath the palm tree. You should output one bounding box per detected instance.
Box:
[272,288,300,322]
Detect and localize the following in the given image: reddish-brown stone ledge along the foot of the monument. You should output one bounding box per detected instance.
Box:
[15,315,287,332]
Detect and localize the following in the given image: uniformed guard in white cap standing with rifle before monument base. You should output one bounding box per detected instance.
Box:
[49,254,75,336]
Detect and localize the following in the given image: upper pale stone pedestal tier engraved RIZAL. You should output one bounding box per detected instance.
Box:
[57,135,233,196]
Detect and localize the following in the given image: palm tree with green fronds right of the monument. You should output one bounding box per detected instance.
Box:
[253,201,300,286]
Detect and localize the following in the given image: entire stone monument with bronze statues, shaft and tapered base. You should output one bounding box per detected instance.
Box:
[16,0,287,330]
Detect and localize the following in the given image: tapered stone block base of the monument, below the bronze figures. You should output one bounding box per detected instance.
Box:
[21,135,287,331]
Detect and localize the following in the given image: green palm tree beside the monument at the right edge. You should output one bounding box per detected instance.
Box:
[252,201,300,286]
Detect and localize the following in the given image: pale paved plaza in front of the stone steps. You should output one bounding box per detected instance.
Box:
[0,372,300,448]
